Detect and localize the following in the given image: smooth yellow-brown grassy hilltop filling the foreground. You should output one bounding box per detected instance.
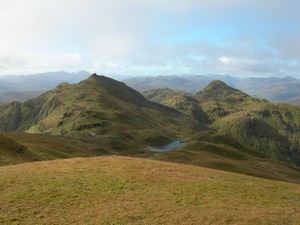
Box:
[0,156,300,224]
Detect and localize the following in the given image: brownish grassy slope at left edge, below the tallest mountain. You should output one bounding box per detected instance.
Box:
[0,132,117,166]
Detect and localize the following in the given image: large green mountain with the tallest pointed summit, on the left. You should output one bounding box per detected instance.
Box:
[0,74,208,142]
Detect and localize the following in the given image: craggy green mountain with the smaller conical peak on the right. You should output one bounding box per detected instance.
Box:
[143,81,300,167]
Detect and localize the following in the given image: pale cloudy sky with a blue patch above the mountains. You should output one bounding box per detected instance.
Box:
[0,0,300,78]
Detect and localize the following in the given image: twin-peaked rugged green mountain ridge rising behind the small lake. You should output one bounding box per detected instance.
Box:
[0,74,300,169]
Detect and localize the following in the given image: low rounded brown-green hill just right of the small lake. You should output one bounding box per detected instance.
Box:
[149,132,300,183]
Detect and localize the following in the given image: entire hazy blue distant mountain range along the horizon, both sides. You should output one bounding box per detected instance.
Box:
[0,71,300,105]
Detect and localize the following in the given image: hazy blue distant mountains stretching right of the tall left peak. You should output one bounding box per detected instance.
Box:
[124,75,300,105]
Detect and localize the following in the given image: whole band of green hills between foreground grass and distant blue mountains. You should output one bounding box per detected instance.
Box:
[0,74,299,183]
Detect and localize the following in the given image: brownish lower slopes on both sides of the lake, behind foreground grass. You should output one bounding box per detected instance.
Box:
[0,131,300,183]
